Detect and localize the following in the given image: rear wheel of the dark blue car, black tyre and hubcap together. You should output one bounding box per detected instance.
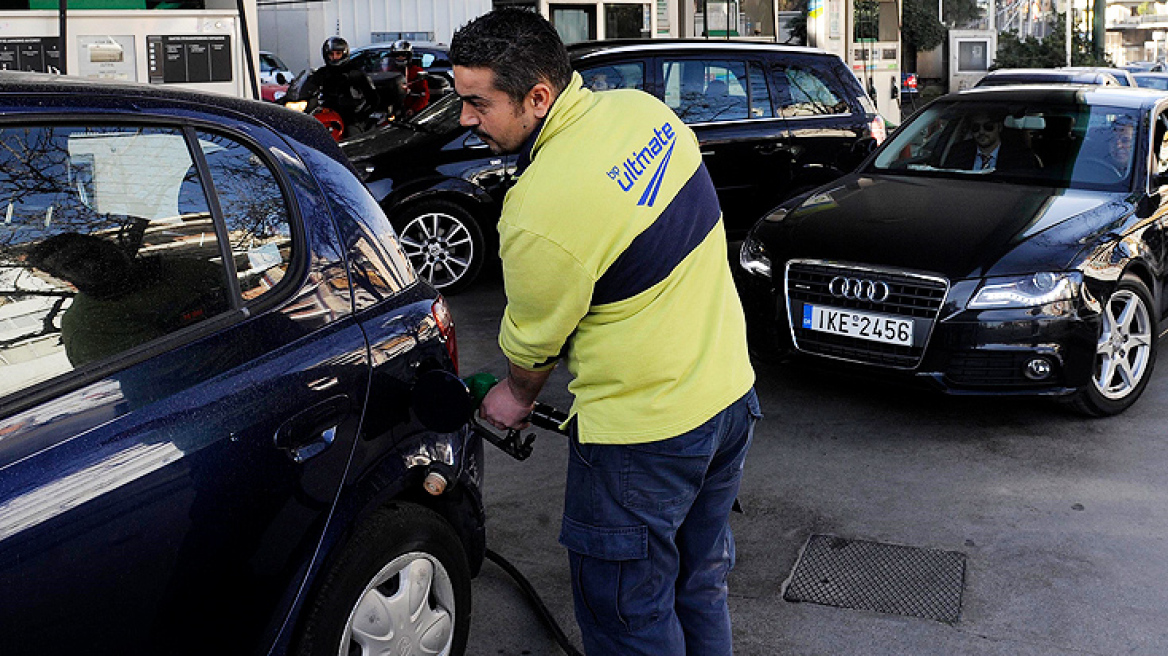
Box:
[297,503,471,656]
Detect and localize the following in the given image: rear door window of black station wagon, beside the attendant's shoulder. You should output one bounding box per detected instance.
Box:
[665,60,752,123]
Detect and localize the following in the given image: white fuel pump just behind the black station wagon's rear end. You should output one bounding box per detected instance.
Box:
[807,0,901,125]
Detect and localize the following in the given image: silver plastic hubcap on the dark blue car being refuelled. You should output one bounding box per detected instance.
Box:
[338,552,454,656]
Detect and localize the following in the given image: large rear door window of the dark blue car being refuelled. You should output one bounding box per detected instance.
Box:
[0,126,231,395]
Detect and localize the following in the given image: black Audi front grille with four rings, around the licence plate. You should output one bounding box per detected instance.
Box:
[784,260,948,369]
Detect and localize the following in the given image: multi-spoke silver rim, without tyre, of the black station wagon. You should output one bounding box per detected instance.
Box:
[401,212,475,289]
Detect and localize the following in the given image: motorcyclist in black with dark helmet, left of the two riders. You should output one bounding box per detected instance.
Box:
[306,36,377,134]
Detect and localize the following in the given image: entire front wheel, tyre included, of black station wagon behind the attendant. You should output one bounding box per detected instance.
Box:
[394,201,487,295]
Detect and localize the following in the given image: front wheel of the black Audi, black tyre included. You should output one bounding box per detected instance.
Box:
[1070,274,1159,417]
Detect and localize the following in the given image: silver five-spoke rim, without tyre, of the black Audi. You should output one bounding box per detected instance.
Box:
[1093,289,1152,400]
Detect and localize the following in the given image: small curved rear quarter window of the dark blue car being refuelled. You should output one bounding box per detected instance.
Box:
[197,132,292,301]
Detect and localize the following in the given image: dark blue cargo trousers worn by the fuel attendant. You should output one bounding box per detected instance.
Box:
[559,390,762,656]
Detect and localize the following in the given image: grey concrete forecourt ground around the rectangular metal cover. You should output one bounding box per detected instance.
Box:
[451,280,1168,656]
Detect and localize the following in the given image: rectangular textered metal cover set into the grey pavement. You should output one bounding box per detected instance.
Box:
[783,536,965,624]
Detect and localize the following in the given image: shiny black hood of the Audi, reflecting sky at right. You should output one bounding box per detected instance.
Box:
[755,174,1133,280]
